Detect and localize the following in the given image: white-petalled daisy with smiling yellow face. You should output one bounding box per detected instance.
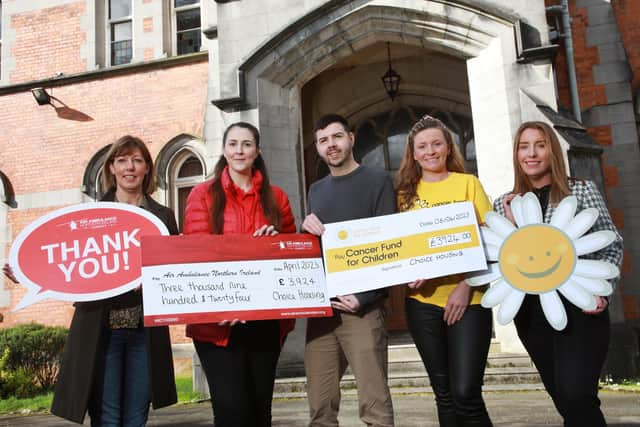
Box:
[467,193,619,330]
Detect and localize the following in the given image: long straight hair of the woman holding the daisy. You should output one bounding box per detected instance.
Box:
[512,122,571,204]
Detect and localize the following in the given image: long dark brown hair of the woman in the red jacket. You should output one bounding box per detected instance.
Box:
[211,122,281,234]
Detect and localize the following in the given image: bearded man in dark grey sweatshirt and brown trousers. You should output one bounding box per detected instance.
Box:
[302,114,396,427]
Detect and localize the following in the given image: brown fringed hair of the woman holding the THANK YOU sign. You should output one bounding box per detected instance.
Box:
[102,135,156,195]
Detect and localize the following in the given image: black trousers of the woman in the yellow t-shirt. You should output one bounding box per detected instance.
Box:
[405,298,492,427]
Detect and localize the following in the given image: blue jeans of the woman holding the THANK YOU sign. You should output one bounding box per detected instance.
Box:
[89,328,151,427]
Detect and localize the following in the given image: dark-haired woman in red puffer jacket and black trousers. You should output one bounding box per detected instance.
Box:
[184,122,296,427]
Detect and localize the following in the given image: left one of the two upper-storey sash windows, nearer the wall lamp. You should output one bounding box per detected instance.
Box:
[109,0,133,65]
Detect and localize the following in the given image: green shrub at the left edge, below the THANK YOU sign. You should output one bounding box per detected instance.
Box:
[0,323,68,390]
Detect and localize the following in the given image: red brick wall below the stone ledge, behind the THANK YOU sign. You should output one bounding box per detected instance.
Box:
[0,58,208,342]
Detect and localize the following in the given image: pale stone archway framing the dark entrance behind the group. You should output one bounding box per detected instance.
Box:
[214,0,532,217]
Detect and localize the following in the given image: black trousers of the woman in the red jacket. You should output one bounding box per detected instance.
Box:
[194,320,280,427]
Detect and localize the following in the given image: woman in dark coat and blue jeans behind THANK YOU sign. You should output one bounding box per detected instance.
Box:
[51,135,178,427]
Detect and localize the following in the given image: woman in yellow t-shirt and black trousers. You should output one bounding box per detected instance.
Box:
[396,116,492,427]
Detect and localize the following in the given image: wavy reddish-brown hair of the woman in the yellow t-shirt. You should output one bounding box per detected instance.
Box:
[396,115,465,210]
